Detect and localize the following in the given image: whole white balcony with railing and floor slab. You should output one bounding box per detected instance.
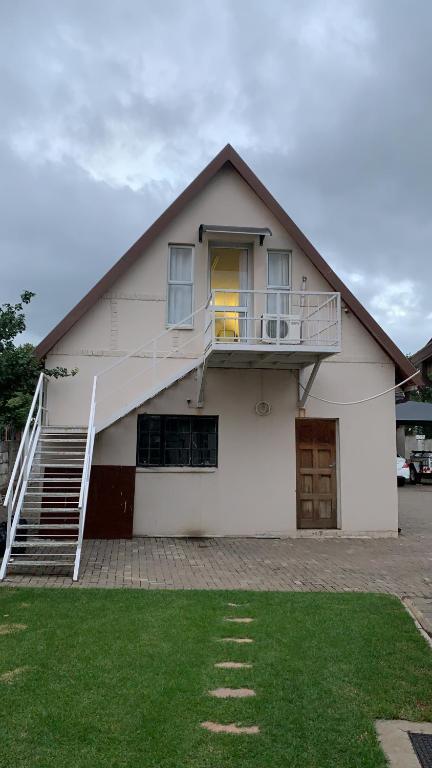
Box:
[205,289,341,368]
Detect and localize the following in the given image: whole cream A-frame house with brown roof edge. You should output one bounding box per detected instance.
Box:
[0,146,415,580]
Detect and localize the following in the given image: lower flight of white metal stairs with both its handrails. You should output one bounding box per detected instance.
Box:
[0,372,96,581]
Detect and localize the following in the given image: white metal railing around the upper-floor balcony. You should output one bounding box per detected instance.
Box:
[205,289,341,352]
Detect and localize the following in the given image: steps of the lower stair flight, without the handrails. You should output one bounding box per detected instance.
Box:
[8,426,87,572]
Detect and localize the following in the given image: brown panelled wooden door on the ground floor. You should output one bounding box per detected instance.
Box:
[296,419,337,528]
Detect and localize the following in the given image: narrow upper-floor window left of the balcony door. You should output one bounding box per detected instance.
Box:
[168,245,193,328]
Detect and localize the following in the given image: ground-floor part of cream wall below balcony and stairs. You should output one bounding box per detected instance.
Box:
[94,362,397,536]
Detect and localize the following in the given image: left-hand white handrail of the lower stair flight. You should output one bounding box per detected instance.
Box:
[0,372,45,580]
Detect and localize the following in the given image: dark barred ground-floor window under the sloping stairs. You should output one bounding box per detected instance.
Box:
[137,413,218,467]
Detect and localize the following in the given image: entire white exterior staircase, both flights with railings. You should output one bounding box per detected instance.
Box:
[0,301,208,581]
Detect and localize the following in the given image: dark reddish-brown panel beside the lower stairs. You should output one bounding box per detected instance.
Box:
[84,465,136,539]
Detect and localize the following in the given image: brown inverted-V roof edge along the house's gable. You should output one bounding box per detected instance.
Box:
[36,144,415,381]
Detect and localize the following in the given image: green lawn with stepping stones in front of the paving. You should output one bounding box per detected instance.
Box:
[0,588,432,768]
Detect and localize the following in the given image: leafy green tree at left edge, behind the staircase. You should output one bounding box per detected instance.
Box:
[0,291,77,429]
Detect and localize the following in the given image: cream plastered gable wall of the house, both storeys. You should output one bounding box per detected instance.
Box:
[43,164,397,535]
